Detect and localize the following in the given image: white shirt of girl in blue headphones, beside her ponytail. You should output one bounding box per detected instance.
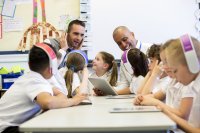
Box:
[59,67,82,96]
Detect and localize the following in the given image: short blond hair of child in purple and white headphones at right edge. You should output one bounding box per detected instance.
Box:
[164,37,200,66]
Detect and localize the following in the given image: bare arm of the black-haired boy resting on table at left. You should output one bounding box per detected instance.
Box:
[35,89,86,110]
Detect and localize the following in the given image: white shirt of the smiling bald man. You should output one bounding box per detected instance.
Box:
[115,40,152,90]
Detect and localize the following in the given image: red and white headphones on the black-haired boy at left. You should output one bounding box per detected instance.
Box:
[35,43,58,74]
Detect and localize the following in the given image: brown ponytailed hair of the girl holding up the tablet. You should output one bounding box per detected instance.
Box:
[99,51,118,86]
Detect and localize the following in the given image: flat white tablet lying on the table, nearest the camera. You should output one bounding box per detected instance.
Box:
[109,106,161,113]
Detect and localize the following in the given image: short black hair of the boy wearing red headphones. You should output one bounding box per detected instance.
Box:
[28,44,57,73]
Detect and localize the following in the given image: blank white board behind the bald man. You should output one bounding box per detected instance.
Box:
[89,0,198,59]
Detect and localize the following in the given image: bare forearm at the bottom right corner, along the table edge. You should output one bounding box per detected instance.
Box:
[163,109,200,133]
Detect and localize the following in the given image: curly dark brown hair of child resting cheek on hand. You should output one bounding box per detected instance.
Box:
[147,44,161,62]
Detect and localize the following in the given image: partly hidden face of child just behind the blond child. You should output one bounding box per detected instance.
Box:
[160,51,174,78]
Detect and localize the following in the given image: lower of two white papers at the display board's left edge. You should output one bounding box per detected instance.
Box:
[3,18,23,32]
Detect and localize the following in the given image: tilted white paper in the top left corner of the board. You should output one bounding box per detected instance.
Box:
[1,0,16,17]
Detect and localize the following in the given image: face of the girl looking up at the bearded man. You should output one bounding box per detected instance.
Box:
[92,53,106,71]
